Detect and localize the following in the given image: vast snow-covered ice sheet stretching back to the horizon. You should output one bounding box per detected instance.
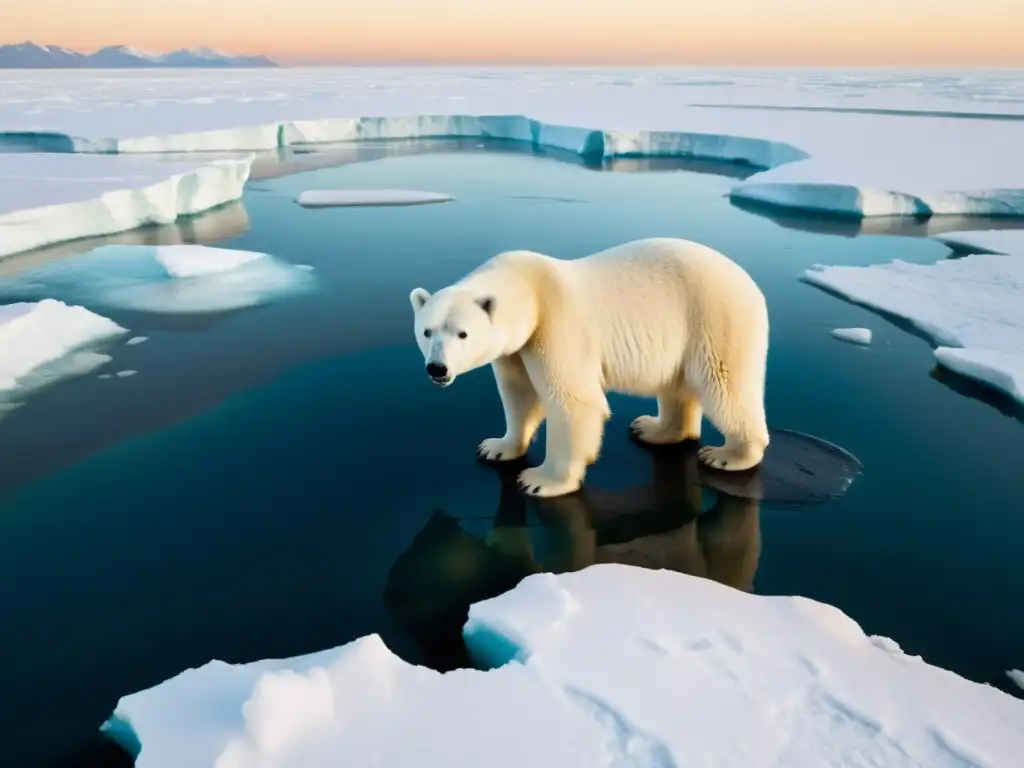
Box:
[0,68,1024,228]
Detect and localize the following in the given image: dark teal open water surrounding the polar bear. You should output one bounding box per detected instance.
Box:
[0,141,1024,766]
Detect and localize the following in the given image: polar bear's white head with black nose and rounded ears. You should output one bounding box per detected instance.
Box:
[409,287,505,387]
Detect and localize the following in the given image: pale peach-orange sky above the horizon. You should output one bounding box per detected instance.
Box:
[0,0,1024,67]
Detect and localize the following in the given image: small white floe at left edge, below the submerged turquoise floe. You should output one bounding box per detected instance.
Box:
[0,299,126,390]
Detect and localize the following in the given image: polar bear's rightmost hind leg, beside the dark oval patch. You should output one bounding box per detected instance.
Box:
[694,354,768,472]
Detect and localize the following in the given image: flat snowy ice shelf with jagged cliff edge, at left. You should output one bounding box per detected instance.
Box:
[0,152,252,258]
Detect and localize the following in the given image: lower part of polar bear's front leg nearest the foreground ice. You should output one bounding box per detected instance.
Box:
[519,403,607,497]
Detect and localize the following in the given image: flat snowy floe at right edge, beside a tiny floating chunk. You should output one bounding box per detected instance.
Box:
[802,254,1024,402]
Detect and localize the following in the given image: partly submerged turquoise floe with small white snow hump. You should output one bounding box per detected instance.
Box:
[0,245,316,313]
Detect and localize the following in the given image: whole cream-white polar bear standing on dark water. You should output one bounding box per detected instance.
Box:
[410,238,768,497]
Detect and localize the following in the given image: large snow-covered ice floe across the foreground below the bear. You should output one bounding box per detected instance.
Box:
[103,564,1024,768]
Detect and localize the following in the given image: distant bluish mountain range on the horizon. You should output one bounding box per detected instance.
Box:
[0,42,278,70]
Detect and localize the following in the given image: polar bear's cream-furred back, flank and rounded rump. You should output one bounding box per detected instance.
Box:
[559,238,768,394]
